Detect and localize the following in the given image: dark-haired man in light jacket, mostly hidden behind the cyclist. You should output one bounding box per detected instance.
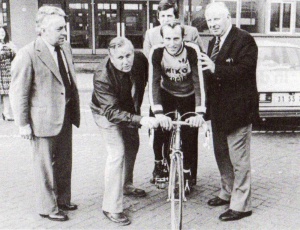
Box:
[143,0,204,185]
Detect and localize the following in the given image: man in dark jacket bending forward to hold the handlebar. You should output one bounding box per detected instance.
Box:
[91,37,158,225]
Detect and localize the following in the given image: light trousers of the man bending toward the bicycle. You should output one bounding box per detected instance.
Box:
[93,114,140,213]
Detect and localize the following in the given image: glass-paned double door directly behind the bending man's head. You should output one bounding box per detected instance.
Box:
[95,0,147,49]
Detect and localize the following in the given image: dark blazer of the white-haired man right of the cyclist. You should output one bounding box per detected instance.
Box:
[206,27,258,132]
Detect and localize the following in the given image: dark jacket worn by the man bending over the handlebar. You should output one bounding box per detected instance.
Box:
[91,51,148,128]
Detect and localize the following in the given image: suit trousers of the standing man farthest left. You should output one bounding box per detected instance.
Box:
[31,106,72,215]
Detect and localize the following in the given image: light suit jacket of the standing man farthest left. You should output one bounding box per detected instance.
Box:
[10,37,80,137]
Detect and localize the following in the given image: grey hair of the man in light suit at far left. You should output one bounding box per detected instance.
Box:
[35,6,66,35]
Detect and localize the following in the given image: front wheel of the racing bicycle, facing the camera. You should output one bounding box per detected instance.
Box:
[169,154,184,230]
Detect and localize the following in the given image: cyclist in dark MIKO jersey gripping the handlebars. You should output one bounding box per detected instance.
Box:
[149,21,206,193]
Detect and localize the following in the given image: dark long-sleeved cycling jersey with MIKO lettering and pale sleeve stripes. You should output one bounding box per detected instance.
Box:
[149,42,206,114]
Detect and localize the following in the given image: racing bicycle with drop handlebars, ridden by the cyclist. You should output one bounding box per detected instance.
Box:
[151,111,209,230]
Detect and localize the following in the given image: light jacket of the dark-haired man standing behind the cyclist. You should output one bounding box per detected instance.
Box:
[143,25,204,58]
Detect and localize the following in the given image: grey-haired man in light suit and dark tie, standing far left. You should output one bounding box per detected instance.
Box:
[10,6,80,221]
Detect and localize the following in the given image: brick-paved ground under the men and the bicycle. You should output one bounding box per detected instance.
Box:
[0,74,300,230]
